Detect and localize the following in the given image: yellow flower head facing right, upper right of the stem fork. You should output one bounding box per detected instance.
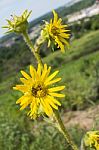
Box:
[41,10,70,52]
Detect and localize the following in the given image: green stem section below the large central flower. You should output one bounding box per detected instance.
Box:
[54,110,78,150]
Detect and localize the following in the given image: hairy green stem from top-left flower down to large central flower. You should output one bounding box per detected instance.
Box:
[22,32,43,67]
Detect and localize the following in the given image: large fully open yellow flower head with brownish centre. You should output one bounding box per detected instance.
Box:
[14,64,65,119]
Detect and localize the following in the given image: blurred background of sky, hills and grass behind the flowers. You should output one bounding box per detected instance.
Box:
[0,0,99,150]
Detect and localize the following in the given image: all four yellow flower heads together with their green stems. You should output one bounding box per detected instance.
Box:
[4,10,99,150]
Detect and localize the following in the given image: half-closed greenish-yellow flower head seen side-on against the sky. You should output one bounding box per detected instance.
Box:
[3,10,32,33]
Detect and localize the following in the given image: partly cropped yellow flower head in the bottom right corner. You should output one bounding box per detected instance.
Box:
[84,131,99,150]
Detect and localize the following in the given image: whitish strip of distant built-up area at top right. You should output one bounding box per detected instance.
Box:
[67,0,99,23]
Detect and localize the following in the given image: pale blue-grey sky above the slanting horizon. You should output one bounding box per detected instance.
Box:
[0,0,71,37]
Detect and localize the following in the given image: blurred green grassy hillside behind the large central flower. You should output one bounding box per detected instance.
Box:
[0,30,99,150]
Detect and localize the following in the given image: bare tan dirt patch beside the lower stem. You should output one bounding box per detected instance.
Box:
[63,105,99,130]
